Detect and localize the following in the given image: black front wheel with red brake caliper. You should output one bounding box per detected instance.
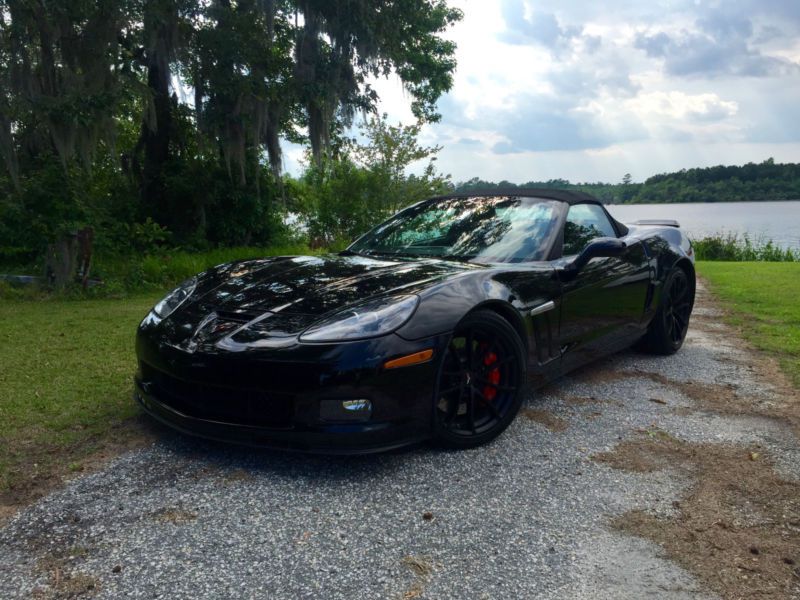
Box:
[433,310,526,449]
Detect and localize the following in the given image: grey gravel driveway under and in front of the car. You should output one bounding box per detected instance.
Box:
[0,284,800,599]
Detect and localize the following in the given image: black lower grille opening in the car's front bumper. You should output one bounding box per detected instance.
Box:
[140,363,294,429]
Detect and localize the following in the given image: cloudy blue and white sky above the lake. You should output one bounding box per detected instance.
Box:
[286,0,800,183]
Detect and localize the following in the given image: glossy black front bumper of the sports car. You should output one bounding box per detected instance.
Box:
[134,335,446,454]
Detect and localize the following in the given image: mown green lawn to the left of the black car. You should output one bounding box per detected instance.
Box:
[0,294,160,506]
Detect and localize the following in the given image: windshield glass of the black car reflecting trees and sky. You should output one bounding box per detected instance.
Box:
[348,196,560,263]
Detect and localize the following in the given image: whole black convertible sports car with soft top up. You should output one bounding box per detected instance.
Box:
[135,190,695,453]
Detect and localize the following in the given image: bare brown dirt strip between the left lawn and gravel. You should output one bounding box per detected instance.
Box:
[0,416,162,527]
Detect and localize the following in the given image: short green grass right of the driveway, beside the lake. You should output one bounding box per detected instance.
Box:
[697,262,800,387]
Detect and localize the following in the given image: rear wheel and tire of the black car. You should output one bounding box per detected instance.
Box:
[641,267,694,356]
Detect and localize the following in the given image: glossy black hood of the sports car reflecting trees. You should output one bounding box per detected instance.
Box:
[165,255,476,350]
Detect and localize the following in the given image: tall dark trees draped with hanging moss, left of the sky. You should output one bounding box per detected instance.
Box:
[0,0,461,262]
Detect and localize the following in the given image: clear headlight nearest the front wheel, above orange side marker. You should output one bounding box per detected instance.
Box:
[300,295,419,342]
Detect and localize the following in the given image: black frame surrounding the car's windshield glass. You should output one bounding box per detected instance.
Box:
[344,192,569,265]
